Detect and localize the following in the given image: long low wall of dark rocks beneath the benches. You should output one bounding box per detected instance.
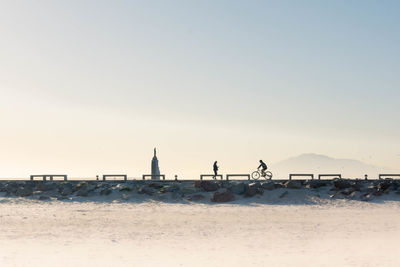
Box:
[0,179,400,203]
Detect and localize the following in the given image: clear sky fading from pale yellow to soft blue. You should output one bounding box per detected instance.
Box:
[0,0,400,178]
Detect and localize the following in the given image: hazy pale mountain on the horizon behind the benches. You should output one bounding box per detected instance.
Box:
[271,153,398,178]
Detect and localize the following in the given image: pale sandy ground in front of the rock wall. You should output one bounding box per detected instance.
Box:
[0,198,400,267]
